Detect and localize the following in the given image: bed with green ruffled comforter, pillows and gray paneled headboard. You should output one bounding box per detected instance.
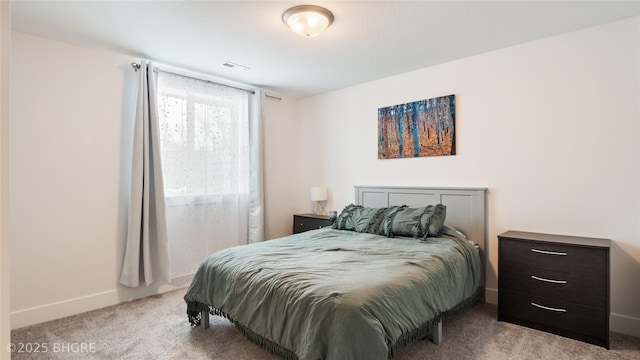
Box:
[184,186,486,359]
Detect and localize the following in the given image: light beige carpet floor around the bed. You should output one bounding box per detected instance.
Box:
[11,290,640,360]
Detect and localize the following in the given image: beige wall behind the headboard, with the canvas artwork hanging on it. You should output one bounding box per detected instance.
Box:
[298,17,640,336]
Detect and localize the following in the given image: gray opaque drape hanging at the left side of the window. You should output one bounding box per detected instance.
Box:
[120,61,170,287]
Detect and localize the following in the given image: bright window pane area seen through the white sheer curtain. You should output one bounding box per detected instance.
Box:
[158,73,248,198]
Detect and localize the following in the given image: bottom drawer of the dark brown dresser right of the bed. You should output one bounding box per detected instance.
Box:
[498,290,609,346]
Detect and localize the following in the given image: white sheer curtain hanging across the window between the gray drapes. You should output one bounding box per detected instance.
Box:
[158,72,263,276]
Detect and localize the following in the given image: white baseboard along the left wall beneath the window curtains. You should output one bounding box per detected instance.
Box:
[11,274,193,330]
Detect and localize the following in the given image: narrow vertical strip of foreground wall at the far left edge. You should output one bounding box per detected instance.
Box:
[0,1,11,359]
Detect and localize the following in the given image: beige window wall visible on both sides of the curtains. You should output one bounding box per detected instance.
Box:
[10,32,298,328]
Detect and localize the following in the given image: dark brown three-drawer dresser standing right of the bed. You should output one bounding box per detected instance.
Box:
[498,231,611,349]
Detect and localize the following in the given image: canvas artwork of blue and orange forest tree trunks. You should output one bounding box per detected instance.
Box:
[378,95,456,159]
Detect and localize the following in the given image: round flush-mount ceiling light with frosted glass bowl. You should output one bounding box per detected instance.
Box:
[282,5,333,37]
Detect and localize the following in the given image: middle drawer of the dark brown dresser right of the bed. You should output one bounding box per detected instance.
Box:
[499,263,607,310]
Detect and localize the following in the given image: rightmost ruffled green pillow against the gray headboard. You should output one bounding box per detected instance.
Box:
[384,204,447,239]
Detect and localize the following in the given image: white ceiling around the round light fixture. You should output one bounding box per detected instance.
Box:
[11,0,640,97]
